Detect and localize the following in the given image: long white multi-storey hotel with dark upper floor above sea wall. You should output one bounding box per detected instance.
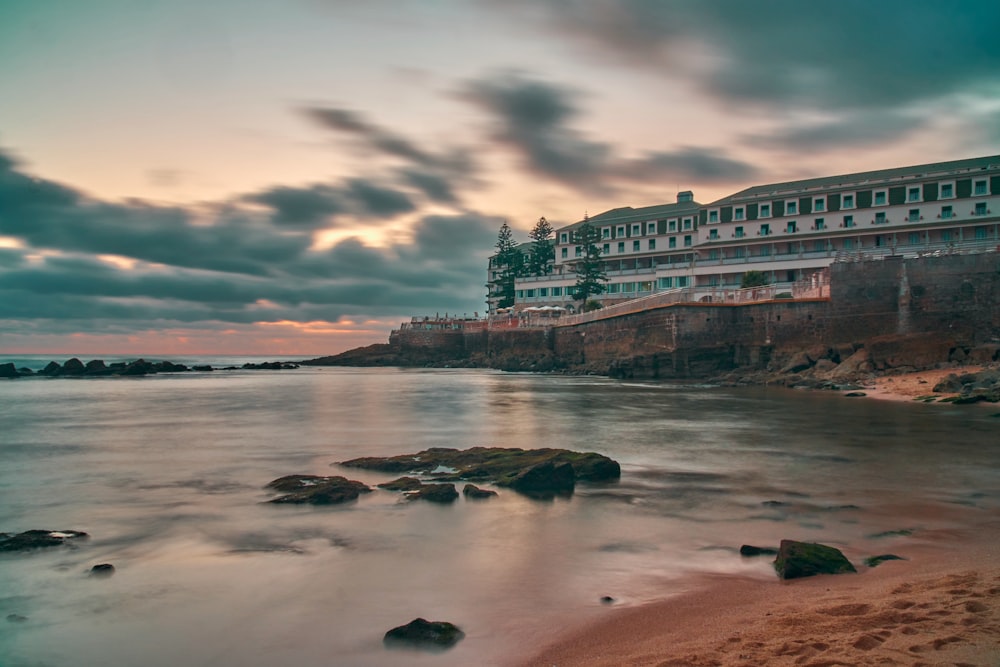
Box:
[498,156,1000,312]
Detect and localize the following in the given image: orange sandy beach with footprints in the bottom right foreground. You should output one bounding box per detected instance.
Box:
[511,518,1000,667]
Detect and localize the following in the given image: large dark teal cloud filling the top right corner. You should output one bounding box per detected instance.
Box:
[504,0,1000,109]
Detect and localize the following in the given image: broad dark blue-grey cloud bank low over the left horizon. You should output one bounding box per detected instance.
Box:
[0,152,500,334]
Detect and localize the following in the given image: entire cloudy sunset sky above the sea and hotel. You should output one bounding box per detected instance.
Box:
[0,0,1000,357]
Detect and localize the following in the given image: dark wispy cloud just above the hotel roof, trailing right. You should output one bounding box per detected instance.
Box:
[463,73,756,192]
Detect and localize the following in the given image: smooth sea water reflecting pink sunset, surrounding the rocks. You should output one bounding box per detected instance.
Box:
[0,358,1000,667]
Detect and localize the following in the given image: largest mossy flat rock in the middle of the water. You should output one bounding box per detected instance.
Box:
[340,447,621,493]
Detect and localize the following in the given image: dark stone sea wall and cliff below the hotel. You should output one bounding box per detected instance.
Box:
[304,252,1000,378]
